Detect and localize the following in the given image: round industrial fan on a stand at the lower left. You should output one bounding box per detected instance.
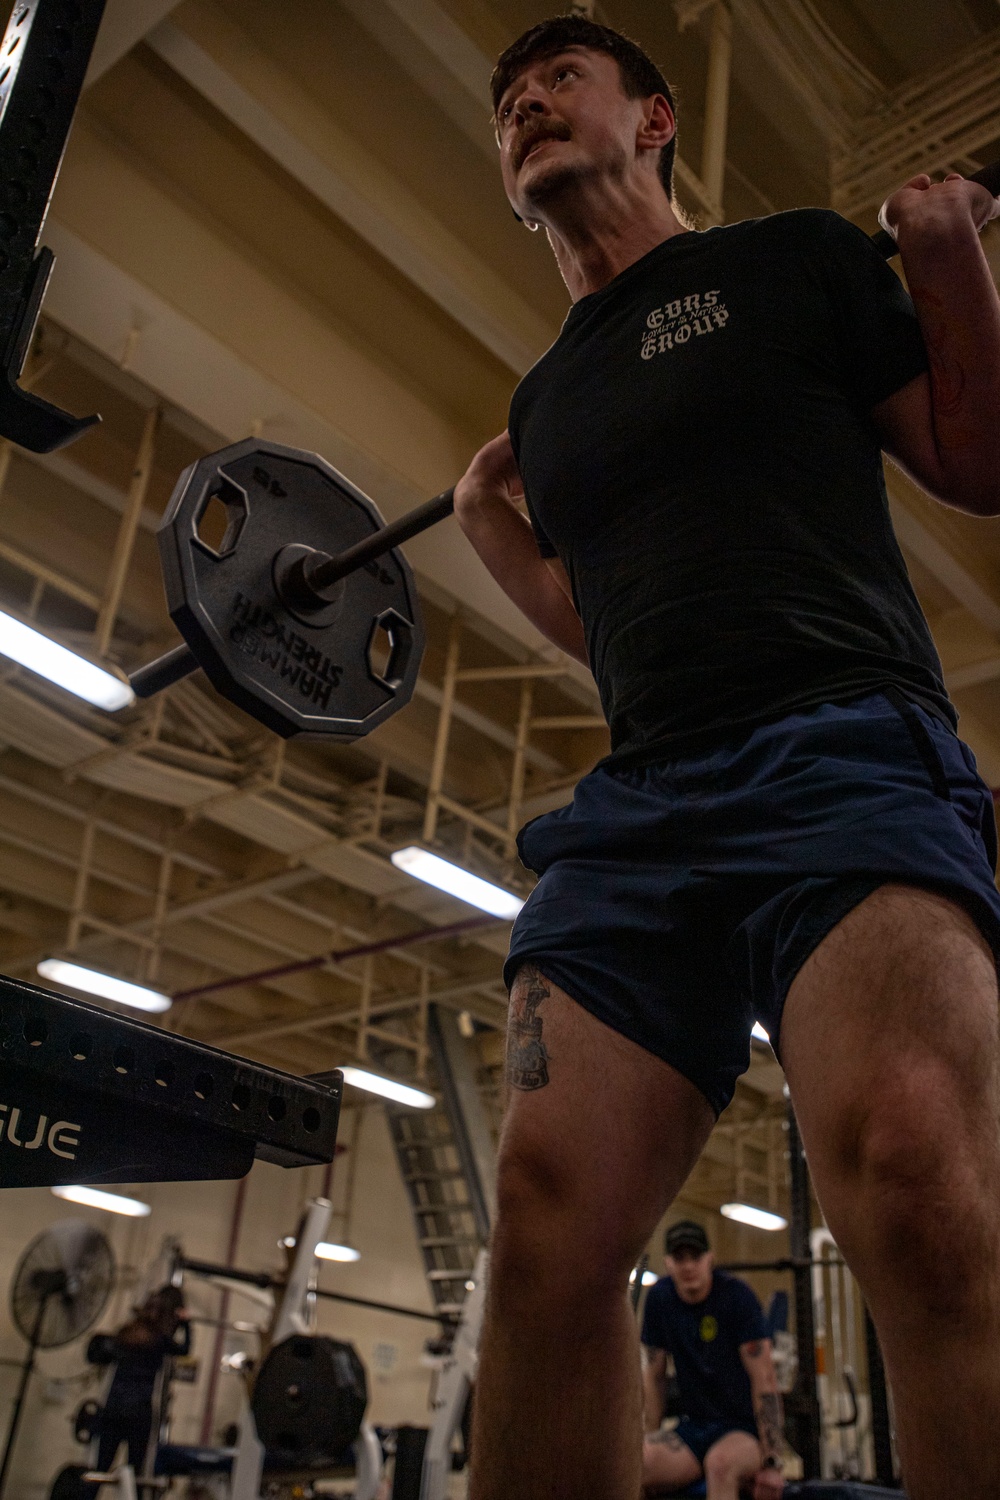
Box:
[0,1220,114,1500]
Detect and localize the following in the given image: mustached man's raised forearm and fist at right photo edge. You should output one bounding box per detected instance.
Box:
[897,204,1000,513]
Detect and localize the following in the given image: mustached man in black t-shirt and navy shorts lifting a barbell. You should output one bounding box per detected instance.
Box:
[456,18,1000,1500]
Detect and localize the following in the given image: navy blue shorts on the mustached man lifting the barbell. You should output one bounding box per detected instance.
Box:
[504,693,1000,1113]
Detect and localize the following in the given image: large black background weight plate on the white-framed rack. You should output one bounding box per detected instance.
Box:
[250,1334,367,1470]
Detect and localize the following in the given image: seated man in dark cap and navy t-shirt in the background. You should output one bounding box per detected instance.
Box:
[642,1220,783,1500]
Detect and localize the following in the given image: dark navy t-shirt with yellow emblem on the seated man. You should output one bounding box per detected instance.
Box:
[642,1271,769,1436]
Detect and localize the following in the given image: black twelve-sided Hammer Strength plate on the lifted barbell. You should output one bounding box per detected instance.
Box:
[157,440,424,741]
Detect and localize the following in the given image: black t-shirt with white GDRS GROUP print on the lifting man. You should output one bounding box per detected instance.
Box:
[510,209,955,764]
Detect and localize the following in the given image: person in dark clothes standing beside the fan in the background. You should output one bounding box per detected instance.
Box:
[97,1286,190,1475]
